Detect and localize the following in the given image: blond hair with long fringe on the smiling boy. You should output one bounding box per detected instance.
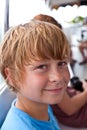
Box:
[0,20,69,91]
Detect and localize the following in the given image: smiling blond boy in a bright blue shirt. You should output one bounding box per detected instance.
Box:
[0,20,70,130]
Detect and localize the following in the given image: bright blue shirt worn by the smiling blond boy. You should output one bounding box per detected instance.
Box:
[1,101,60,130]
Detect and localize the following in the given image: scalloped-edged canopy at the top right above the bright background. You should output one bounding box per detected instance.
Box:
[45,0,87,9]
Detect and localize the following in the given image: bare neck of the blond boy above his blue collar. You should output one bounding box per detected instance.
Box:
[15,96,49,121]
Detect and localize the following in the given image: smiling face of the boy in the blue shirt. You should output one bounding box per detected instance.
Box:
[20,60,70,104]
